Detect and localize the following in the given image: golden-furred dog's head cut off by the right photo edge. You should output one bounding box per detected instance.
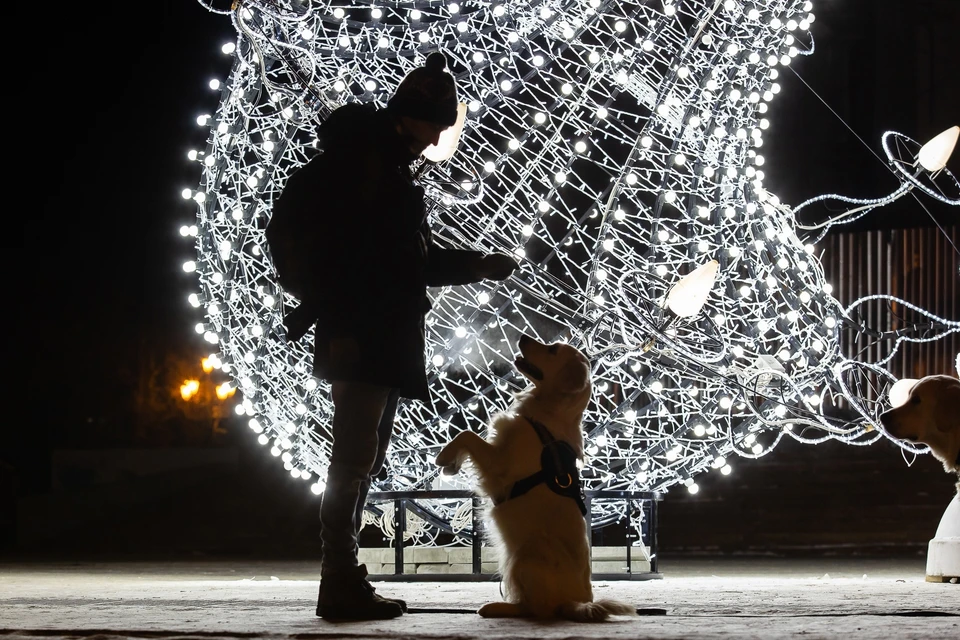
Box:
[880,375,960,488]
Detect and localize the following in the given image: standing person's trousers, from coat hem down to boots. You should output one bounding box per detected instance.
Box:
[320,381,399,577]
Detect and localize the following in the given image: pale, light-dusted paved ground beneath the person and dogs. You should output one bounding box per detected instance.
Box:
[0,557,960,640]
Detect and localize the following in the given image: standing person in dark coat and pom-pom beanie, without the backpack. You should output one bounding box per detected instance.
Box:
[300,53,518,620]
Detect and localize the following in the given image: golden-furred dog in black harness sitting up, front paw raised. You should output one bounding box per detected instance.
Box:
[437,336,636,622]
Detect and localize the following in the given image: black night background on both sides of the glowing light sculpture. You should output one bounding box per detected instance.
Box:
[0,0,960,557]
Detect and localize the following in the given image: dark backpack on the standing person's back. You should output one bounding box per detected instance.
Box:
[265,153,332,302]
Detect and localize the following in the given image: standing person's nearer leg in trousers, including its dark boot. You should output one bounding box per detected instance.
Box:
[317,381,403,619]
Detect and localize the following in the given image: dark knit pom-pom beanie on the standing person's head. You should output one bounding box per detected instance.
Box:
[387,51,457,127]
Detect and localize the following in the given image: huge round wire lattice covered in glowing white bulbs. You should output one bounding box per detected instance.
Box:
[183,0,960,526]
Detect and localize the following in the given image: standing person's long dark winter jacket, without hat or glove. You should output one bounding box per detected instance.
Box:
[284,105,482,402]
